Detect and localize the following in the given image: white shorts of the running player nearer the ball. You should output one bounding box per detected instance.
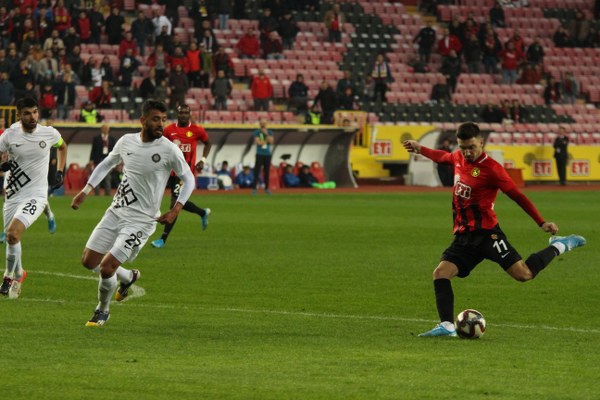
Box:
[85,208,156,263]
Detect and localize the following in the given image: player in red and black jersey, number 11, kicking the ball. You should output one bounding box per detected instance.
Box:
[403,122,585,336]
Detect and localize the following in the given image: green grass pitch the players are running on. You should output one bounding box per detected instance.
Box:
[0,190,600,400]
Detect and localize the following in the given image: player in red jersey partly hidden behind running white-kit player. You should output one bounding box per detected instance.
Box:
[152,105,212,248]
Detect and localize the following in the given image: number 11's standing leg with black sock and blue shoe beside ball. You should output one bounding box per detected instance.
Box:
[419,260,458,337]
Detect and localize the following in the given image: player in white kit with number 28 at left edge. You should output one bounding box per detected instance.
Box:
[0,98,67,299]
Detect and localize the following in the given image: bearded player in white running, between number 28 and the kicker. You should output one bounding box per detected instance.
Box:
[71,100,195,326]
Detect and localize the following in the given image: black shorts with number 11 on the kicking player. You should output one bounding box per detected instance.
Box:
[442,225,522,278]
